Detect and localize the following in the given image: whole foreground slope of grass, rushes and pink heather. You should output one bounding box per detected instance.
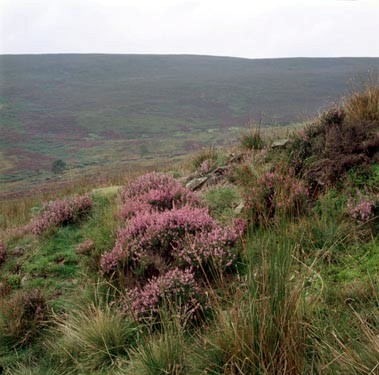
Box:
[0,86,379,375]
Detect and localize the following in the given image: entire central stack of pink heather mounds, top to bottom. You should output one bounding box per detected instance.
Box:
[101,174,246,324]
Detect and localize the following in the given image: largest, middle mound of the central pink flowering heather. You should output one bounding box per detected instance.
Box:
[101,206,238,277]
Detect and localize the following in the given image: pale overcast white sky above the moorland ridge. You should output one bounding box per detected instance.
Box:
[0,0,379,58]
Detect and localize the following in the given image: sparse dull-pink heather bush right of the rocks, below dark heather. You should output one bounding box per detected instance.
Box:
[247,172,308,222]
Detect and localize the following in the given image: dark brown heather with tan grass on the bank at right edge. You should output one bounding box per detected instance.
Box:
[288,86,379,186]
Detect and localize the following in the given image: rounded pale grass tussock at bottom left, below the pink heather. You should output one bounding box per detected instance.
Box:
[49,305,139,374]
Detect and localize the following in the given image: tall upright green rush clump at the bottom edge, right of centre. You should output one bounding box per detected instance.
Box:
[191,231,309,375]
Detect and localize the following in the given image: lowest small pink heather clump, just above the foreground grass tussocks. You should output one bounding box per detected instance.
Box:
[127,268,204,319]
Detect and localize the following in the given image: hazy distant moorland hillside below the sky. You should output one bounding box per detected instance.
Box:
[0,55,379,197]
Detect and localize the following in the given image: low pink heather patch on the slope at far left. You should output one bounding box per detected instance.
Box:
[31,196,92,235]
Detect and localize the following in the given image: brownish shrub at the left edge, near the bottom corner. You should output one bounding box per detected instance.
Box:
[0,289,50,346]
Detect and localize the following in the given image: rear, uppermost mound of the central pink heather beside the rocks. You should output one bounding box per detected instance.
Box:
[121,172,198,218]
